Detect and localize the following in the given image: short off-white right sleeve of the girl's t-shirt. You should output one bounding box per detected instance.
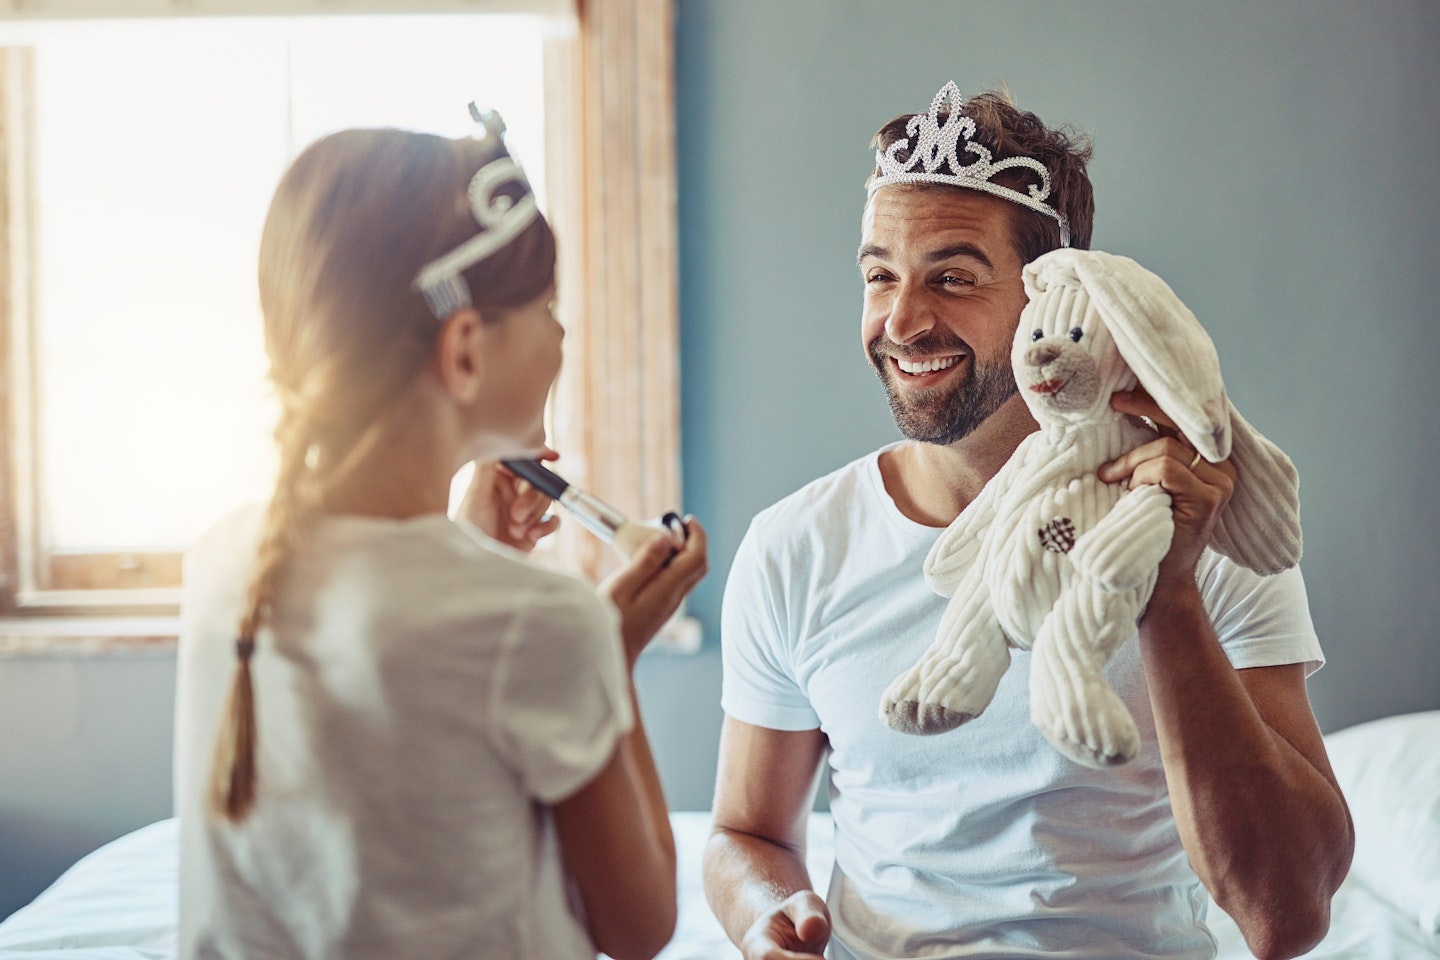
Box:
[490,583,635,803]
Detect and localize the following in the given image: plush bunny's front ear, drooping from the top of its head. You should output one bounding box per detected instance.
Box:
[1076,250,1231,463]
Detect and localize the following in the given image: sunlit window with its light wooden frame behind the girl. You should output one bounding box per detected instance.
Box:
[0,0,678,651]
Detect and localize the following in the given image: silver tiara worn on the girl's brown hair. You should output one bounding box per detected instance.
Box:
[415,104,540,321]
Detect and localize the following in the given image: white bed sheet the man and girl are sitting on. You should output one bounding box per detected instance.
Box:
[0,813,1440,960]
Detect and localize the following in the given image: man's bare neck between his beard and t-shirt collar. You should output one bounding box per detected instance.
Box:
[880,394,1037,527]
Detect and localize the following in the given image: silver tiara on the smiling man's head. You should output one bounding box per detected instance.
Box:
[868,81,1070,246]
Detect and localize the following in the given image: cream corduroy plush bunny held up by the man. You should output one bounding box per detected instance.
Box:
[880,249,1300,767]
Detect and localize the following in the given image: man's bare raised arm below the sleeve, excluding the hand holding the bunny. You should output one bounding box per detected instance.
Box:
[1140,587,1355,960]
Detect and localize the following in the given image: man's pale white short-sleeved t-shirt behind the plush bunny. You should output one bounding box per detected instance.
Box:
[721,453,1322,960]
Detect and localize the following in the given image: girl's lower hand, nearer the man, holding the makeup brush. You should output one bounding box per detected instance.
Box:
[599,517,708,666]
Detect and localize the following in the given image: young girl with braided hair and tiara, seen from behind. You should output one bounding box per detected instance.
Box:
[176,114,706,960]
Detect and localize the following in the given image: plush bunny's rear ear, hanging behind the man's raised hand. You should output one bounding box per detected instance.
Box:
[1210,404,1302,574]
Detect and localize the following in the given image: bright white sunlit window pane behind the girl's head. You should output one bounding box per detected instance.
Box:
[16,16,544,553]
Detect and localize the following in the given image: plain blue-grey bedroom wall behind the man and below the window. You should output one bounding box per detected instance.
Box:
[0,0,1440,917]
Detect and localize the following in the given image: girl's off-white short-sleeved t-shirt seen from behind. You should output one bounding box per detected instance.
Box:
[176,510,634,960]
